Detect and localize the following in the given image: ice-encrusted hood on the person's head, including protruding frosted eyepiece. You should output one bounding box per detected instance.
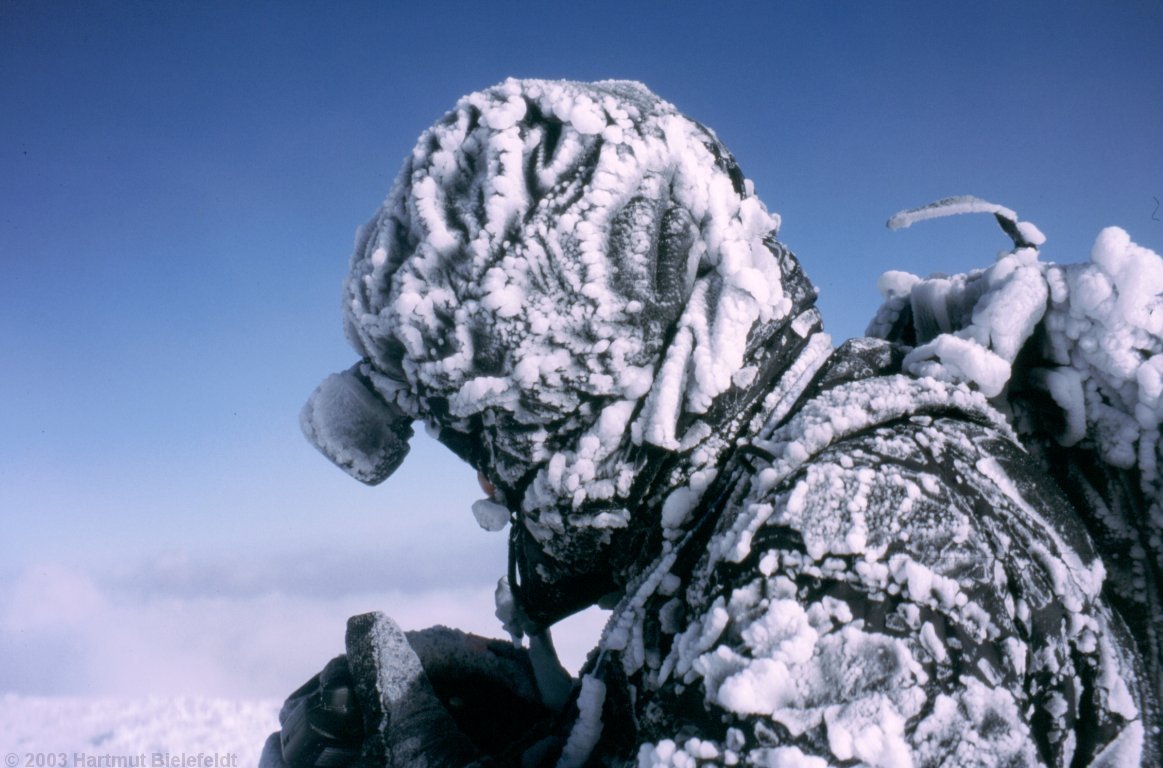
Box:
[302,80,818,623]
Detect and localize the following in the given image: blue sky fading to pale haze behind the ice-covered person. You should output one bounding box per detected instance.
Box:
[0,0,1163,695]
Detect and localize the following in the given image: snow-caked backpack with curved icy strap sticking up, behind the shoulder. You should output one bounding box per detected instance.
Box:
[869,198,1163,721]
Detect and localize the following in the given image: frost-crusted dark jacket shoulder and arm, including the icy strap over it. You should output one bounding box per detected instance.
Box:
[567,341,1157,767]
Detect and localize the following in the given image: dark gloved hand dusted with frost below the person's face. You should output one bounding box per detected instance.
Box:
[259,613,559,768]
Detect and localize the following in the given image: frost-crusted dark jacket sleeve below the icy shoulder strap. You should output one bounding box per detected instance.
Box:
[662,407,1143,765]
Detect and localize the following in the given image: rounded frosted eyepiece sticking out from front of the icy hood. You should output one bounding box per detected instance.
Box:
[299,365,413,485]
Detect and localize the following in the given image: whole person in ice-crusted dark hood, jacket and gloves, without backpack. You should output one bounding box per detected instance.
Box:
[263,80,1163,768]
